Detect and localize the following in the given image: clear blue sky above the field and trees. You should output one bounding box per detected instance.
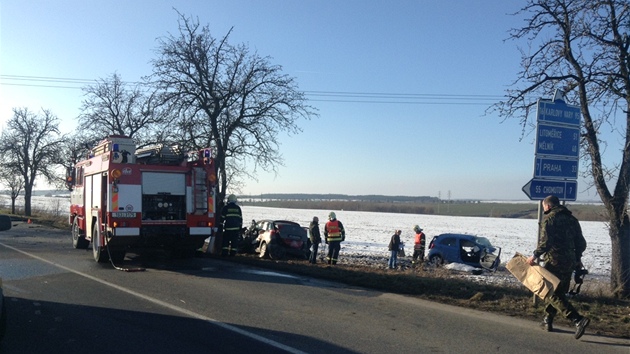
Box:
[0,0,596,200]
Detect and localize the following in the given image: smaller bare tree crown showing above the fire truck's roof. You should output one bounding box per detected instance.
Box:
[78,73,169,144]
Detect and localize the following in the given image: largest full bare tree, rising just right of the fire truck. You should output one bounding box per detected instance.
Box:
[151,14,316,207]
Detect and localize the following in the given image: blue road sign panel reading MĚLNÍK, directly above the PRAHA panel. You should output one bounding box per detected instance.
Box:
[536,122,580,159]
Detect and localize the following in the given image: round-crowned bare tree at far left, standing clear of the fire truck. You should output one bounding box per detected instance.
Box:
[0,108,64,216]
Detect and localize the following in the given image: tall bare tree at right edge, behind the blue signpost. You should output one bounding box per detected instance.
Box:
[495,0,630,297]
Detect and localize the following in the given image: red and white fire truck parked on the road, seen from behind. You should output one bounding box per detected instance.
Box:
[67,136,217,263]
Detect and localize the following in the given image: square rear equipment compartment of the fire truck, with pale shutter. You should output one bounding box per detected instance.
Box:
[142,172,186,220]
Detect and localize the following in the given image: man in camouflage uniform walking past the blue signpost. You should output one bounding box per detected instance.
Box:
[527,195,590,339]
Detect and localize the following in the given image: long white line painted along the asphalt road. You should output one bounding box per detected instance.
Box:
[0,242,306,354]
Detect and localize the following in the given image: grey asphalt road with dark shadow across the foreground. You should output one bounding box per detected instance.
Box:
[0,223,630,354]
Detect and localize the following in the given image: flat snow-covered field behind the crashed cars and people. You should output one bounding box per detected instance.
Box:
[0,195,611,277]
